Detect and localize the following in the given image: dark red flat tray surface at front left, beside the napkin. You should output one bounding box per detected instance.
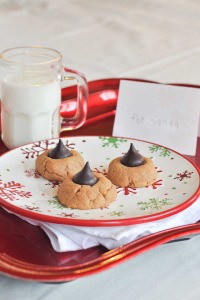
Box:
[0,208,107,266]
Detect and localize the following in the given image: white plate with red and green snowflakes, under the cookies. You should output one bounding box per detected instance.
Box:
[0,136,199,226]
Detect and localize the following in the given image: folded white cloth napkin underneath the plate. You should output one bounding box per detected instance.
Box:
[4,197,200,252]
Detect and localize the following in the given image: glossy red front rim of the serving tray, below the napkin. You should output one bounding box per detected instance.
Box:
[0,223,200,283]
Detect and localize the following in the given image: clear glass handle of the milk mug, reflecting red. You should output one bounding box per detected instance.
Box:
[61,68,88,132]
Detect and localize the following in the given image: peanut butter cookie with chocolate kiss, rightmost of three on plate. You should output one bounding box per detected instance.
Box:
[107,143,157,188]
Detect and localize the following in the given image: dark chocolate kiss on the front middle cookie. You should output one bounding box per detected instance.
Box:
[73,162,98,186]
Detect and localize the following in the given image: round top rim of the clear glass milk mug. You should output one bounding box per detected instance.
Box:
[0,46,62,66]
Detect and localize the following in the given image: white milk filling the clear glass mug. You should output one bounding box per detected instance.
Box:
[1,76,61,149]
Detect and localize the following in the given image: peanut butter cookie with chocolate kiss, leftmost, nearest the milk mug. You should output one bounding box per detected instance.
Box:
[35,139,84,181]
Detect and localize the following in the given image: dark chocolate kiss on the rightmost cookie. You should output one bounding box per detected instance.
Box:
[121,143,145,167]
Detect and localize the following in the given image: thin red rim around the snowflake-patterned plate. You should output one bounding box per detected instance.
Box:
[0,135,200,227]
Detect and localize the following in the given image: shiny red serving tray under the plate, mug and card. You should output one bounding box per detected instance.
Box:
[0,78,200,282]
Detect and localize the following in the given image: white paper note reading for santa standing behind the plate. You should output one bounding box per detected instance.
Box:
[113,80,200,156]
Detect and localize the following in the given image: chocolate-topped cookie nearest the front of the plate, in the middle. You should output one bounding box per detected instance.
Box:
[58,162,117,209]
